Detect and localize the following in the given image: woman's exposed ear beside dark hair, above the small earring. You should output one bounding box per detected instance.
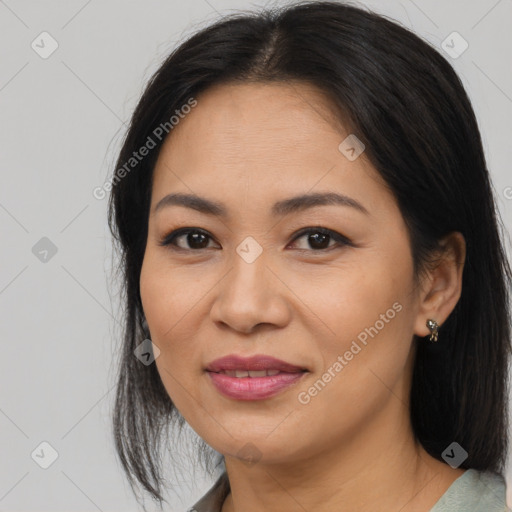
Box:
[414,231,466,337]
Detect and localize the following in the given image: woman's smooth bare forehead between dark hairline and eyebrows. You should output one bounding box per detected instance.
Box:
[152,83,390,216]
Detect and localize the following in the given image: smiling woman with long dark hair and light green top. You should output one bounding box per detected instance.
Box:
[106,2,511,512]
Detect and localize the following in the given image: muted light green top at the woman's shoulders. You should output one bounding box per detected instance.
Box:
[188,469,512,512]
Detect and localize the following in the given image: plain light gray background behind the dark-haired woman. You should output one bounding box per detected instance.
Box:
[0,0,512,512]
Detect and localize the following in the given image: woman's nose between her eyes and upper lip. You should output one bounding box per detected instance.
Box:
[210,249,291,334]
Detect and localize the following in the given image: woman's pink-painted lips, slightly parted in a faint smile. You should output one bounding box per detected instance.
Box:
[206,355,308,400]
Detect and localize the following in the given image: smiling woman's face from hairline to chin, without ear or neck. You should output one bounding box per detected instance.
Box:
[140,84,426,462]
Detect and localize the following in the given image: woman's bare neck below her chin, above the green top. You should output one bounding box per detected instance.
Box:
[222,396,464,512]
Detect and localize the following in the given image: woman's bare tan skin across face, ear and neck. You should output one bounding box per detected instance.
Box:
[140,83,465,512]
